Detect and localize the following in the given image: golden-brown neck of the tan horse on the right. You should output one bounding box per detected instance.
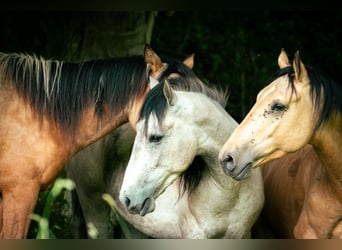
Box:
[311,114,342,193]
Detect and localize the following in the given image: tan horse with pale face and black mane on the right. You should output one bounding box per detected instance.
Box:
[219,50,342,238]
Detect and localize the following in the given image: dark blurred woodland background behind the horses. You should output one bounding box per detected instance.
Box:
[0,10,342,238]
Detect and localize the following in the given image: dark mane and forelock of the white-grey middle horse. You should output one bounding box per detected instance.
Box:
[139,60,228,194]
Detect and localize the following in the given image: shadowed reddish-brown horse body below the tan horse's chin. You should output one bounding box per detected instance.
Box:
[253,144,324,239]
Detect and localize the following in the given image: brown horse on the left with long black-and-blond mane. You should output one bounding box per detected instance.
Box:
[0,45,166,239]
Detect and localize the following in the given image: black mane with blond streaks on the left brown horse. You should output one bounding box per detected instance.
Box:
[0,53,149,136]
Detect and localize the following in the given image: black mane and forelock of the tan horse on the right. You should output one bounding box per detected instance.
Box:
[268,66,342,130]
